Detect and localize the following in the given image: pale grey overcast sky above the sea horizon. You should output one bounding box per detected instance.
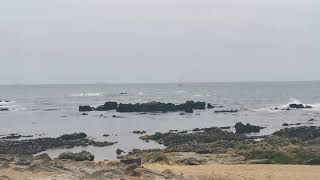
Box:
[0,0,320,84]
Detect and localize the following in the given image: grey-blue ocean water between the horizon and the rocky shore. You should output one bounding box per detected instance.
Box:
[0,81,320,160]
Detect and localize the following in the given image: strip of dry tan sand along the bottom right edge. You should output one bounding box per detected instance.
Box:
[144,164,320,180]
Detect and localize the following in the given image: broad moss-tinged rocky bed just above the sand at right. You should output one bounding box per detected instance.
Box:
[129,126,320,165]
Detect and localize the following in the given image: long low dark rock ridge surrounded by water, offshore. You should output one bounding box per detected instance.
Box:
[79,101,206,113]
